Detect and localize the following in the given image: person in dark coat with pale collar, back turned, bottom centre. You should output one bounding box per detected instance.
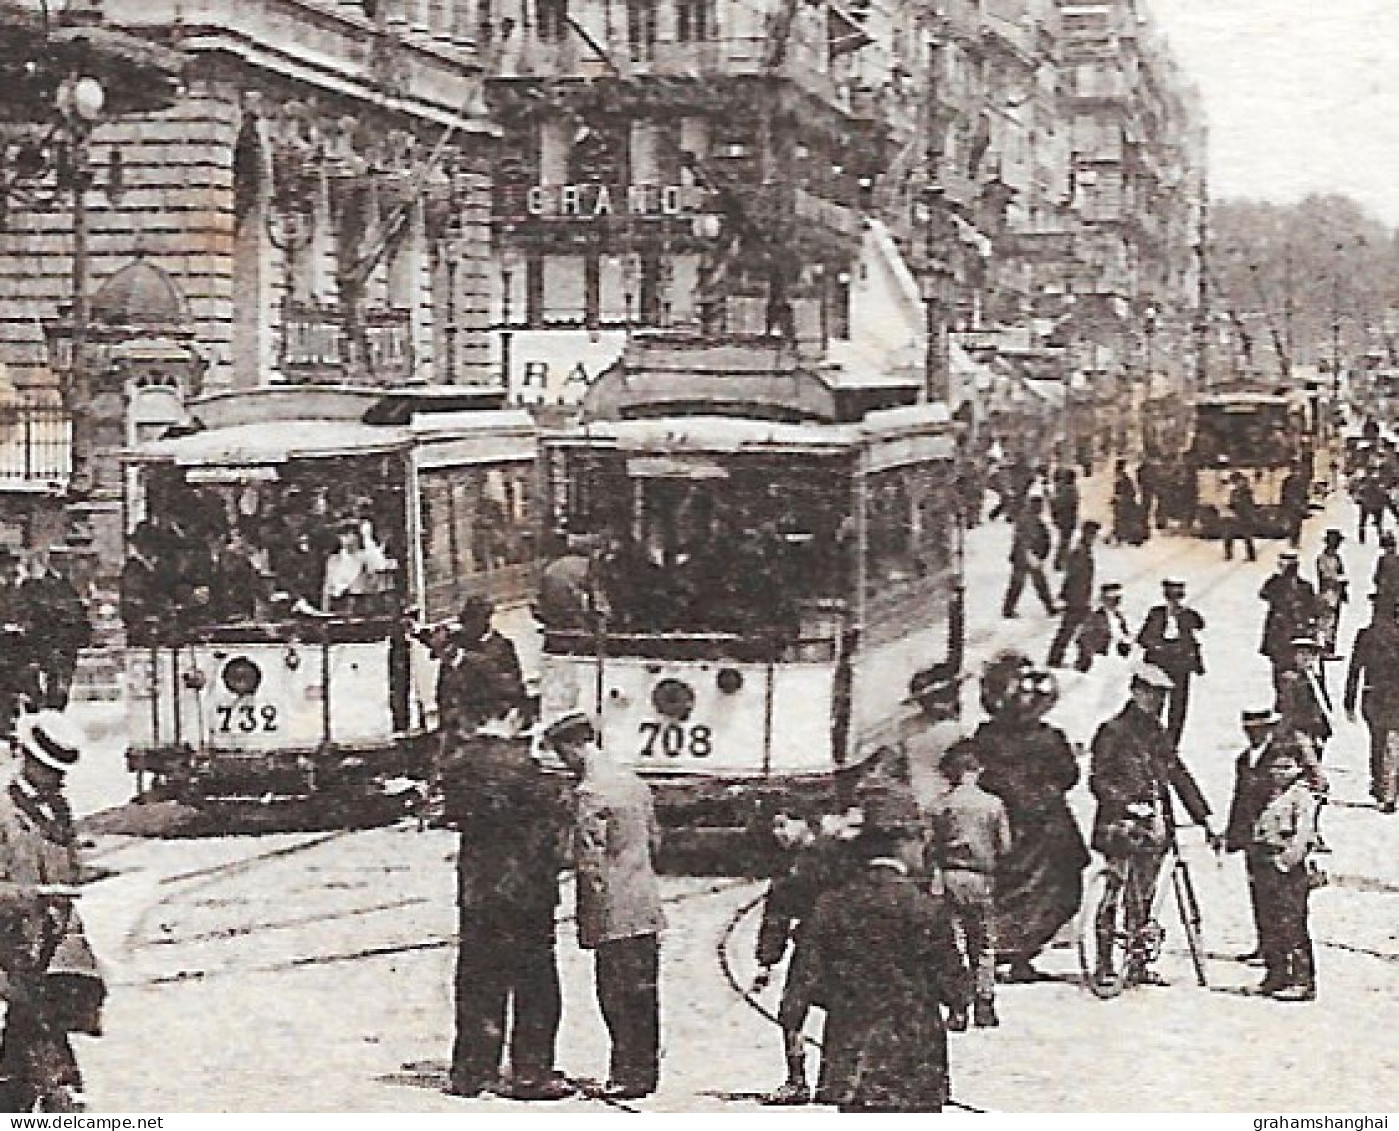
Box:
[811,815,971,1111]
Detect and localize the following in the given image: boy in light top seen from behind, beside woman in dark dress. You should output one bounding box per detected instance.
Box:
[929,743,1010,1030]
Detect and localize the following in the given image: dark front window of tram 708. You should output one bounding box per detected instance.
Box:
[551,469,846,644]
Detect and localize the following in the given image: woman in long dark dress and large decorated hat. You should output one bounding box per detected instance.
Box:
[964,652,1091,981]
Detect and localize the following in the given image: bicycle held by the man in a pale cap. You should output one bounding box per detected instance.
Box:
[1079,824,1209,999]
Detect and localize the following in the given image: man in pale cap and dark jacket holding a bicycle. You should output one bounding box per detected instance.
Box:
[1088,663,1220,985]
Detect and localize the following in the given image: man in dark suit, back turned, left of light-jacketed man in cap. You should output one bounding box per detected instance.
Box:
[442,714,572,1100]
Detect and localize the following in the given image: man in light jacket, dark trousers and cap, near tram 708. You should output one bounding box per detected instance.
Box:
[543,711,666,1099]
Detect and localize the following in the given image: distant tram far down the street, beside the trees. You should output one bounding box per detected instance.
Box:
[1189,392,1311,538]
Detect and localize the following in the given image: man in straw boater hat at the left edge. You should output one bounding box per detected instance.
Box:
[0,711,105,1111]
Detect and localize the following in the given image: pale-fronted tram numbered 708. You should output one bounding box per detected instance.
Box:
[541,340,964,827]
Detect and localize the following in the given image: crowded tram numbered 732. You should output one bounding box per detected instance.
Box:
[123,389,539,805]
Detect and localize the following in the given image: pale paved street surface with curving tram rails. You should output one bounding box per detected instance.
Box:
[54,481,1399,1111]
